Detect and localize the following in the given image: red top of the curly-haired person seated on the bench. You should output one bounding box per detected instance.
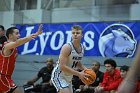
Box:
[101,69,121,91]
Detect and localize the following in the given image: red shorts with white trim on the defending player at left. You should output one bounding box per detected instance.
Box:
[0,74,16,92]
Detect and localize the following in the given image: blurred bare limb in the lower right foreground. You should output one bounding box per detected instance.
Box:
[117,44,140,93]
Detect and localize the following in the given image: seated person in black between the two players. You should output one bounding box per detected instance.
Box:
[27,58,54,93]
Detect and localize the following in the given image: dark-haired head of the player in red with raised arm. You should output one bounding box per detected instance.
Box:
[6,27,20,41]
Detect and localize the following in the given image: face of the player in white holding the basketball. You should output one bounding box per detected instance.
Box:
[72,29,82,41]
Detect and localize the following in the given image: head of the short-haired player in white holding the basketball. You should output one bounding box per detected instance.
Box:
[72,25,83,40]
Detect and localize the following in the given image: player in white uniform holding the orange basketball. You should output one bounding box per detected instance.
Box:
[51,25,88,93]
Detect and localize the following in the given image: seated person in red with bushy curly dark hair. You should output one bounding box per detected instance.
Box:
[95,59,121,93]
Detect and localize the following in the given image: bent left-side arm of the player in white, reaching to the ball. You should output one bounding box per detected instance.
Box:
[59,44,80,76]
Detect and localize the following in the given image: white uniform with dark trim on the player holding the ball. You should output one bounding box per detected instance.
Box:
[51,42,84,89]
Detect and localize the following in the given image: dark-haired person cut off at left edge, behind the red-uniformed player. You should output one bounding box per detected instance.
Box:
[0,25,7,50]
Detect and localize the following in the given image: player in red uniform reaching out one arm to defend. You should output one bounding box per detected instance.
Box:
[0,25,42,93]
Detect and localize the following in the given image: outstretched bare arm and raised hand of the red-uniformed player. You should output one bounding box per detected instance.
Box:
[4,24,42,50]
